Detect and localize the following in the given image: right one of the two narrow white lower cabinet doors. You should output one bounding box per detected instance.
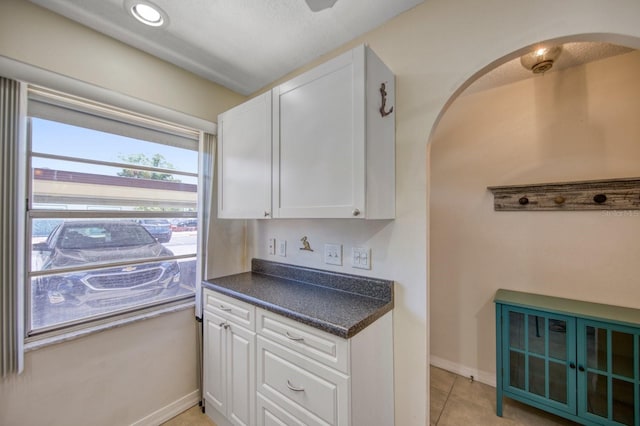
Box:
[227,323,256,426]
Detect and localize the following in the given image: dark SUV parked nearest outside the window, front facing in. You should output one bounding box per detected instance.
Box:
[33,220,180,305]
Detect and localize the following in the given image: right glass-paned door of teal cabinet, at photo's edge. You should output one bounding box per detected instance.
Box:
[578,320,640,426]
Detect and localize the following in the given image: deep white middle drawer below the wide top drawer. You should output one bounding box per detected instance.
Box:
[257,336,349,426]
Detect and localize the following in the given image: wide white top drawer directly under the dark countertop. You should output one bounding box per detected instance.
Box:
[257,309,349,373]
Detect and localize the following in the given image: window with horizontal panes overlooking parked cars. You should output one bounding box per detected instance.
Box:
[26,87,200,336]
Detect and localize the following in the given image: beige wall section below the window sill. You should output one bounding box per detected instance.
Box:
[0,309,198,426]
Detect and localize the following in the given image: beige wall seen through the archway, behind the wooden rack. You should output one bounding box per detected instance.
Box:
[430,51,640,383]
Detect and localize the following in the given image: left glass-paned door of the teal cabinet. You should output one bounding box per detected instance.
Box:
[502,306,576,414]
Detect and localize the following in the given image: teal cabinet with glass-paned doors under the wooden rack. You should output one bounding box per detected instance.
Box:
[495,290,640,426]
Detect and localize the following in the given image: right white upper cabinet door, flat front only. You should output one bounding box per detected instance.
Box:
[273,48,365,218]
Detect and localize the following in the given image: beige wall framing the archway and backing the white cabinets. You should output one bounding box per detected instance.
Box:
[248,0,640,426]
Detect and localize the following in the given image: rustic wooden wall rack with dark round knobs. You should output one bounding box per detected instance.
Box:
[487,178,640,211]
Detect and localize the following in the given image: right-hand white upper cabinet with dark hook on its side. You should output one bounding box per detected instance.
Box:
[272,46,395,219]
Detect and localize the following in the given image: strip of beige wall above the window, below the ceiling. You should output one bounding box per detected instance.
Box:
[0,0,244,121]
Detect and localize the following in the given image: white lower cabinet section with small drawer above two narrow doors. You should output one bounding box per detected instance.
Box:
[203,291,256,426]
